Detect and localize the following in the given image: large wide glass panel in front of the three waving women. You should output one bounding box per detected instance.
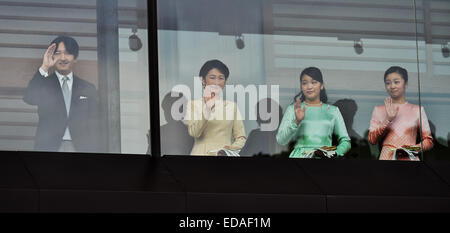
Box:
[158,0,423,159]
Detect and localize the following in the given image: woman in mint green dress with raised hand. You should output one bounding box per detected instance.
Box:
[277,67,351,158]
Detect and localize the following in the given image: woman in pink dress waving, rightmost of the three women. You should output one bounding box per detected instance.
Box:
[369,66,433,161]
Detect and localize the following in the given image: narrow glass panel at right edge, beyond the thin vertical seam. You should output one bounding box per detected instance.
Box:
[418,0,450,160]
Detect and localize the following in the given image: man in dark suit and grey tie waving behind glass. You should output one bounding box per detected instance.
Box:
[23,36,100,152]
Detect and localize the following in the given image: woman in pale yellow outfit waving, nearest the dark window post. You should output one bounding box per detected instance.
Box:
[184,60,246,155]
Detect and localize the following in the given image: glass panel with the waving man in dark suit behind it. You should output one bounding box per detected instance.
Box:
[0,0,149,153]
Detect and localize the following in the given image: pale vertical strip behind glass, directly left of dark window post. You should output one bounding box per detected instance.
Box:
[118,0,150,154]
